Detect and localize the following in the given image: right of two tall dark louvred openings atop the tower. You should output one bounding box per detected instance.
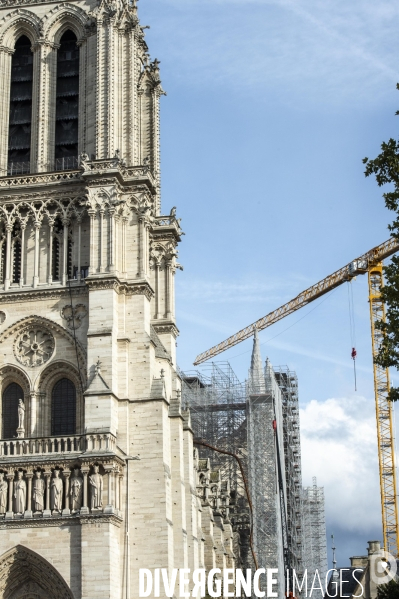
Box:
[55,31,79,170]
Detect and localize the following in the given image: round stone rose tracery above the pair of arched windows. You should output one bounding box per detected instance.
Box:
[14,327,55,366]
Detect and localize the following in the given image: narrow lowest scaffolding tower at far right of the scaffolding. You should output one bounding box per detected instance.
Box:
[302,477,328,599]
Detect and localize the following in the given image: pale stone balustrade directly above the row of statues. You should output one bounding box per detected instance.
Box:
[0,433,116,458]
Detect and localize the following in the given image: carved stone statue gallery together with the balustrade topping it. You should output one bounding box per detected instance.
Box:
[0,454,124,522]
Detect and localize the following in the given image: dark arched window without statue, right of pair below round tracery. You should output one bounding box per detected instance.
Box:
[51,378,76,435]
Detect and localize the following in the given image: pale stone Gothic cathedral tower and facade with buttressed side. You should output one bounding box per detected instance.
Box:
[0,0,234,599]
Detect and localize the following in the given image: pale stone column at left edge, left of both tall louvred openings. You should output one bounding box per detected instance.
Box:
[0,46,14,177]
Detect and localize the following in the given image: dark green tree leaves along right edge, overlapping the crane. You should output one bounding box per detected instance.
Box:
[363,90,399,401]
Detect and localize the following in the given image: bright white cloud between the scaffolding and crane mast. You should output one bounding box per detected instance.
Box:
[300,396,381,534]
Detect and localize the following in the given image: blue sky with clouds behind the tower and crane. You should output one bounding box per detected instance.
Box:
[139,0,399,565]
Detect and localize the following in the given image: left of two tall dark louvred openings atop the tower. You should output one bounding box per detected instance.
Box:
[8,35,33,175]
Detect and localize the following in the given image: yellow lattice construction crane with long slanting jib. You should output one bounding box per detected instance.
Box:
[194,239,399,557]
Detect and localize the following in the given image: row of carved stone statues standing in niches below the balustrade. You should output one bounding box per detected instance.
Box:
[0,465,103,514]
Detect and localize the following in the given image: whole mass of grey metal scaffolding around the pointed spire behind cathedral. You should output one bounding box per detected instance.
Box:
[181,354,327,596]
